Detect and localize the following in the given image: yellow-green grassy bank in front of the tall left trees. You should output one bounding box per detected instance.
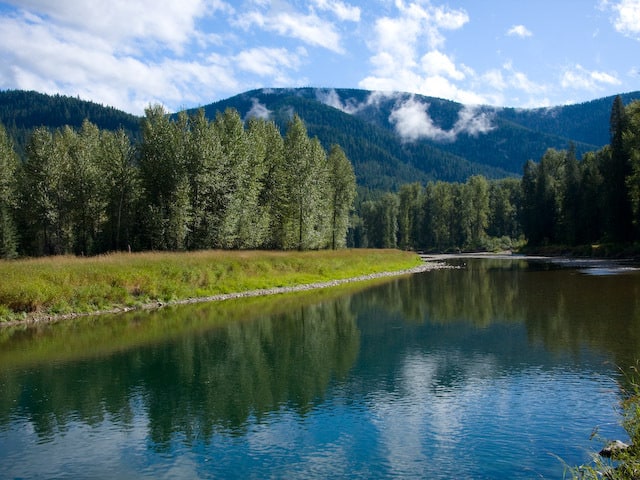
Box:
[0,249,421,321]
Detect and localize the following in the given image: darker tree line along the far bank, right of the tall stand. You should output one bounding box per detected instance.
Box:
[350,96,640,251]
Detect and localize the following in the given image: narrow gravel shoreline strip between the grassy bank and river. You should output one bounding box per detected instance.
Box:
[0,261,449,328]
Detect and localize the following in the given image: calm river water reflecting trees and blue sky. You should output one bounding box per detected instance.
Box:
[0,259,640,479]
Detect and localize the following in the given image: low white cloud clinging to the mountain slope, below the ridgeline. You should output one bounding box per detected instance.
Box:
[389,96,494,142]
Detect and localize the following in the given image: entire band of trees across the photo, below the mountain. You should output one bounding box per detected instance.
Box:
[0,96,640,258]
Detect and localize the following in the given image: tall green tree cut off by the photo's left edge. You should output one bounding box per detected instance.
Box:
[0,124,18,258]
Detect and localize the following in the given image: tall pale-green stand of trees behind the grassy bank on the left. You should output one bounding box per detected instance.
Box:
[0,106,355,258]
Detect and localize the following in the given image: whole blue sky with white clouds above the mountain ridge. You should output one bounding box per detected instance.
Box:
[0,0,640,115]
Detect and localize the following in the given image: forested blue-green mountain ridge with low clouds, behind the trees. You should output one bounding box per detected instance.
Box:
[0,88,640,190]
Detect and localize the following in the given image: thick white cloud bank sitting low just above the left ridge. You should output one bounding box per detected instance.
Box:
[0,10,245,114]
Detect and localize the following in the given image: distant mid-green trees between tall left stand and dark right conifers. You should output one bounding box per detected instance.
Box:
[351,176,522,251]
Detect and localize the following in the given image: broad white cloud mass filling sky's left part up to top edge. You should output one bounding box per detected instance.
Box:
[0,0,318,114]
